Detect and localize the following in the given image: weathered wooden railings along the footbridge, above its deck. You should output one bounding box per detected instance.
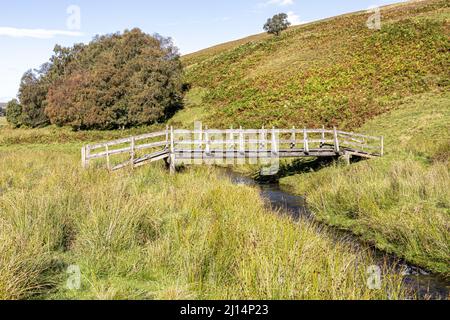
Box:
[82,127,384,169]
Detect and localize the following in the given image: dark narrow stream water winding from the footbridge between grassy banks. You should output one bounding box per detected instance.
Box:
[220,169,450,300]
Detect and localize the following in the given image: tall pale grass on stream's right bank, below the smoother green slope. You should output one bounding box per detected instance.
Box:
[286,160,450,275]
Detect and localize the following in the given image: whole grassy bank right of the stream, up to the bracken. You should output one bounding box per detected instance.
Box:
[282,94,450,277]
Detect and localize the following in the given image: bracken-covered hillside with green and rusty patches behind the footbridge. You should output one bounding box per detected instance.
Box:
[172,0,450,129]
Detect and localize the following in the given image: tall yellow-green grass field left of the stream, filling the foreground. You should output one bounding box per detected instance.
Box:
[0,122,403,299]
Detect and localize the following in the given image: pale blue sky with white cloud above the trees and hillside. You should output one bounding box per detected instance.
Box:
[0,0,399,102]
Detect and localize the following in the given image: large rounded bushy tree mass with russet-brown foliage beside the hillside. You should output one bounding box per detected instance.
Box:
[7,29,182,129]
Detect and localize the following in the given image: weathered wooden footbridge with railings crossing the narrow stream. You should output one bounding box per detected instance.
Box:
[81,127,384,173]
